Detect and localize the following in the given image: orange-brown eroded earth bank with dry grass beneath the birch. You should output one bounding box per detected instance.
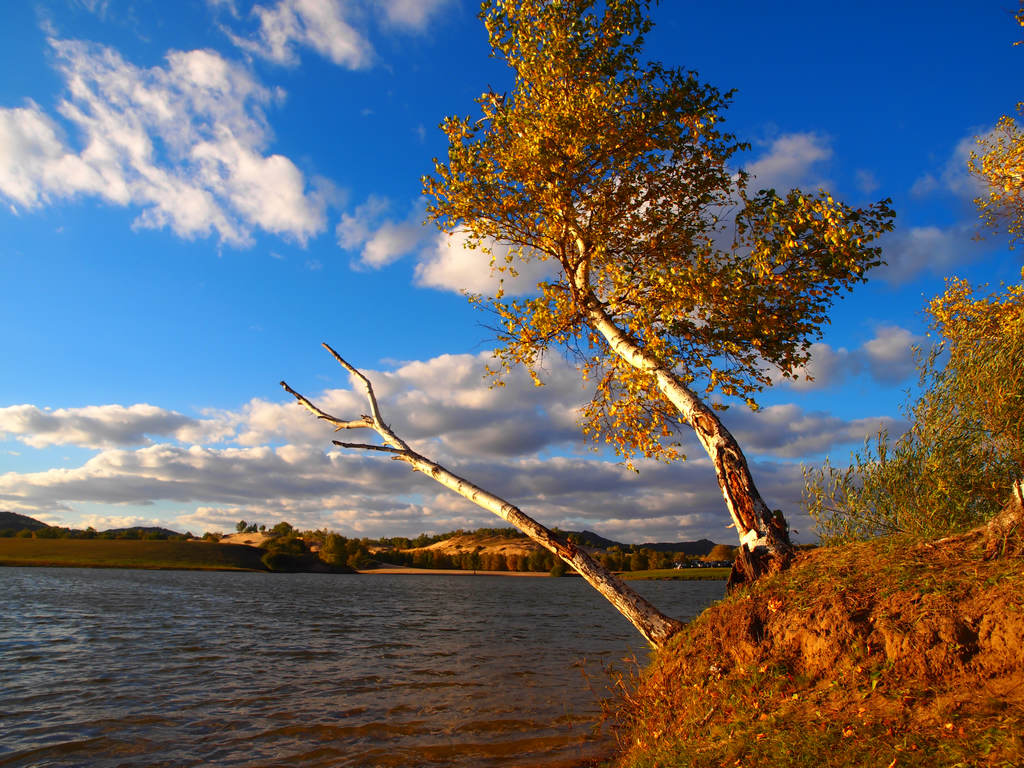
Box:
[611,512,1024,768]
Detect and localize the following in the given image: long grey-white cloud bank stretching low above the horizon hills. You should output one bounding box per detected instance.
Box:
[0,348,898,541]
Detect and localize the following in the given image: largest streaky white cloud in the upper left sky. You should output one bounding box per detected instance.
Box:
[0,39,326,245]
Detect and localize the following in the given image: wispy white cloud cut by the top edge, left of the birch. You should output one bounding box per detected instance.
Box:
[228,0,374,70]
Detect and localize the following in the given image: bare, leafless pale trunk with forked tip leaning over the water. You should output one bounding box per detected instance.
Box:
[281,344,683,647]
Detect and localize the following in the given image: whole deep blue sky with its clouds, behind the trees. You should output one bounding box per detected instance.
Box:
[0,0,1024,542]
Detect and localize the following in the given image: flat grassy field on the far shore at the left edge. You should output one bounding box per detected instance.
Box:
[0,539,266,570]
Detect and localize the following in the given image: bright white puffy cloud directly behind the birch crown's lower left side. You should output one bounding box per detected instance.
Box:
[416,232,555,296]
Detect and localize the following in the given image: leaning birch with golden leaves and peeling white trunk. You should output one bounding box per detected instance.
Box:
[424,0,893,585]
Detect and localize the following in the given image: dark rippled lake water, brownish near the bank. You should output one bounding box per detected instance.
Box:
[0,567,725,768]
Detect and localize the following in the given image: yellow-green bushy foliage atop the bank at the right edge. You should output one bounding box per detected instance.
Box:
[804,272,1024,544]
